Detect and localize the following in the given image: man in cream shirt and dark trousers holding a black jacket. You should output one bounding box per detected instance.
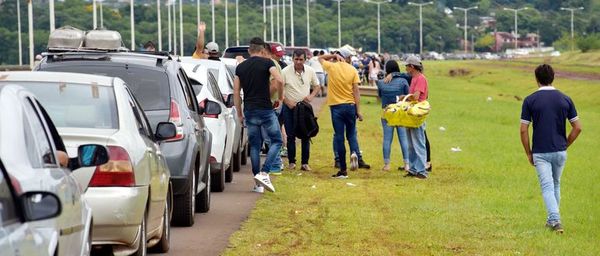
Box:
[281,50,321,171]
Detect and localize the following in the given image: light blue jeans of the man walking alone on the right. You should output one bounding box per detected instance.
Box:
[533,151,567,224]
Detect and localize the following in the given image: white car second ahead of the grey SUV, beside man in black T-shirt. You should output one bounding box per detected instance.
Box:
[181,57,249,172]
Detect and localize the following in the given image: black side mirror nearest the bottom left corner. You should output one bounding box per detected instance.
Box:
[20,191,62,221]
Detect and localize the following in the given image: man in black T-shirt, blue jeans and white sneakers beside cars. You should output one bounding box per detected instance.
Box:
[233,37,283,193]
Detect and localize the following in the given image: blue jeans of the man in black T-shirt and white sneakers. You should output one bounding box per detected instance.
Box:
[244,109,282,175]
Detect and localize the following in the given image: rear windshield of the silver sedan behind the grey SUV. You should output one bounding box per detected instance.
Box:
[19,82,118,129]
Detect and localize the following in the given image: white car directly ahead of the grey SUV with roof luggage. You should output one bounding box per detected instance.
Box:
[181,63,236,182]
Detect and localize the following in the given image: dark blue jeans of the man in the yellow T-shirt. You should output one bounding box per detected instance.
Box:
[329,104,358,172]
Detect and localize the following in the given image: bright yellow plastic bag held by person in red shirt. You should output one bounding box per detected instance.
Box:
[382,94,431,128]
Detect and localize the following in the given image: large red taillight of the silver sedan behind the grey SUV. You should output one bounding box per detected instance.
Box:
[89,146,135,187]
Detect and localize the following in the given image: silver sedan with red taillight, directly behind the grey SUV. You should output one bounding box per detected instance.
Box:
[0,72,176,255]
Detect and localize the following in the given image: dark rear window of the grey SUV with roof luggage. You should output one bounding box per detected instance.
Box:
[44,65,171,111]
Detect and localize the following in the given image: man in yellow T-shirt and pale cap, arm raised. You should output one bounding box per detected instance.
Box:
[319,47,363,179]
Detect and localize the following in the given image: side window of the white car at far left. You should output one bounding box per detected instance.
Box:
[23,98,57,168]
